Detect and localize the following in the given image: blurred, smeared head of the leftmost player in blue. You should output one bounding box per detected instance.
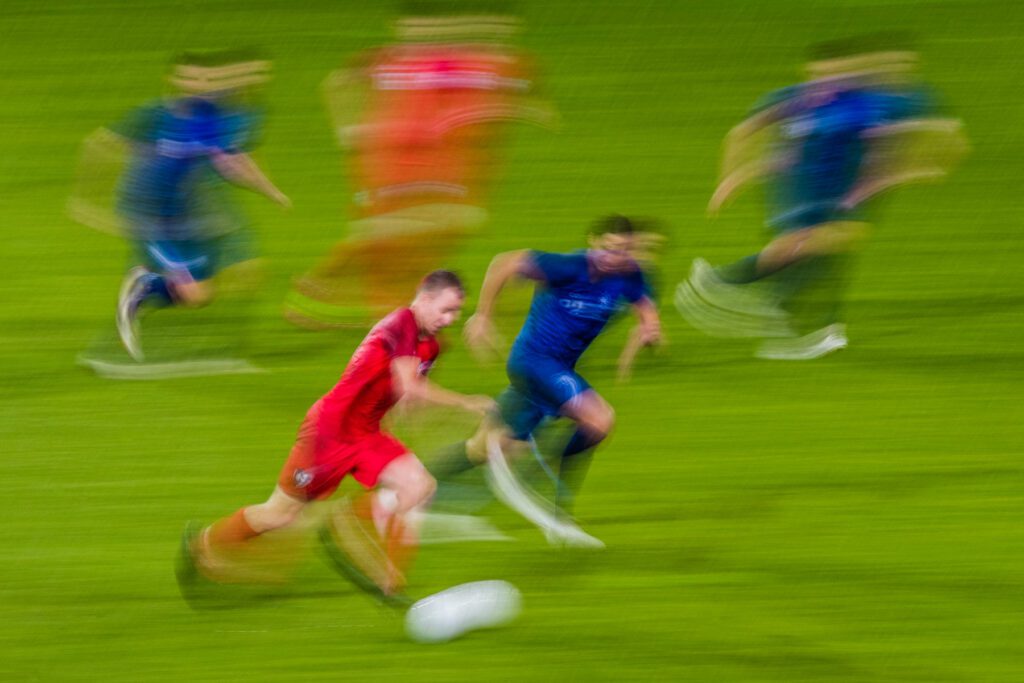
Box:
[168,48,270,97]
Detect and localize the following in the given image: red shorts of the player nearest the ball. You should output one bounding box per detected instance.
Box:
[278,411,409,501]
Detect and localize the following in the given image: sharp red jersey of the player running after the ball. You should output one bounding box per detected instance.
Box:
[317,308,440,441]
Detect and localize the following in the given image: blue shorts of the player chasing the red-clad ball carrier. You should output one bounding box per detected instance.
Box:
[498,356,590,440]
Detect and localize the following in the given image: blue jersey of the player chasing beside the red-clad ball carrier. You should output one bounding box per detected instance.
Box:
[511,251,649,368]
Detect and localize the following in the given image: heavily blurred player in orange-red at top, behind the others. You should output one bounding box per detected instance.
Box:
[286,1,555,328]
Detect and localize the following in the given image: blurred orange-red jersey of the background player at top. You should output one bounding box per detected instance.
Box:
[352,45,531,215]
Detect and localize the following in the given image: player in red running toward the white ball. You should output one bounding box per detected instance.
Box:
[178,270,493,599]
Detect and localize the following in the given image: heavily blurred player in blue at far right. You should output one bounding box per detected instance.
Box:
[676,35,964,359]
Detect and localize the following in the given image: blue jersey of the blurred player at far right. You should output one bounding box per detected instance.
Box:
[766,83,930,223]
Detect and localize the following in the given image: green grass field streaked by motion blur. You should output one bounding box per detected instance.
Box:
[0,0,1024,683]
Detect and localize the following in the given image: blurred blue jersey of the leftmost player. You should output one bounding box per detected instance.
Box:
[112,98,246,237]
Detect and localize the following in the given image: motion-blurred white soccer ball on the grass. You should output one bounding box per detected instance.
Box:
[406,581,522,643]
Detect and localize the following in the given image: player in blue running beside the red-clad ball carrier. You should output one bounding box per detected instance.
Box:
[428,216,660,545]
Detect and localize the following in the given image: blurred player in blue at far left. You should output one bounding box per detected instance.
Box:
[72,50,289,374]
